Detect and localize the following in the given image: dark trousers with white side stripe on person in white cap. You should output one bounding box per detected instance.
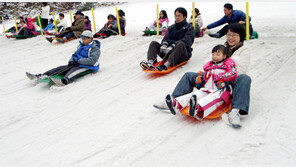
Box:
[43,65,92,82]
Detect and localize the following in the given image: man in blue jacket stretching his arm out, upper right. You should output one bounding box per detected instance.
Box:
[203,3,253,38]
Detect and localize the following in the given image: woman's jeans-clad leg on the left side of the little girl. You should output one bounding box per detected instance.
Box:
[172,72,198,98]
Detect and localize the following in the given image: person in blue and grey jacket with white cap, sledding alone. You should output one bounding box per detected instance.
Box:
[26,31,101,86]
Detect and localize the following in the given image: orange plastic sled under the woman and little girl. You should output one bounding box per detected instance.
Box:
[181,99,232,119]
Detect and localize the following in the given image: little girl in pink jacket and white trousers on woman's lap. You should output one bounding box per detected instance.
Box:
[166,45,237,120]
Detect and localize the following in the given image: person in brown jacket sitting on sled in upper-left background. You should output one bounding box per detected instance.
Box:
[46,11,84,43]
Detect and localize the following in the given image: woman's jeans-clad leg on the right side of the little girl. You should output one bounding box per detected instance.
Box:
[231,74,252,115]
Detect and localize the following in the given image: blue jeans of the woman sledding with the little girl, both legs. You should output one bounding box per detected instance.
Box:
[172,72,251,115]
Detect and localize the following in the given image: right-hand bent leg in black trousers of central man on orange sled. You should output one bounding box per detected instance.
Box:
[167,42,190,66]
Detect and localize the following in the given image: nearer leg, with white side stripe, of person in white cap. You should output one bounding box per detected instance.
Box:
[62,67,92,85]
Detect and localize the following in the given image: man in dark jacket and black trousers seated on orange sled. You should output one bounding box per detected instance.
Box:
[140,7,195,71]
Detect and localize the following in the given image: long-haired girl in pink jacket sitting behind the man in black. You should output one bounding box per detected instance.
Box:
[143,10,169,36]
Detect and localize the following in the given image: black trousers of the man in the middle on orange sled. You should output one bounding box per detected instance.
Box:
[147,41,190,66]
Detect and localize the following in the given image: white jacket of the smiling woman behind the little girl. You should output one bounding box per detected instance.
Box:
[231,43,251,75]
